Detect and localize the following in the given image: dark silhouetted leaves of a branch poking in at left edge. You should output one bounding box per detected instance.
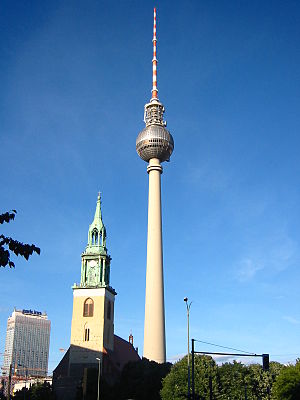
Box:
[0,210,41,268]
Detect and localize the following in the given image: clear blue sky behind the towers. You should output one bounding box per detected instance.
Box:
[0,0,300,371]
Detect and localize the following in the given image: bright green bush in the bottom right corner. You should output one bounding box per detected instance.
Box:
[273,359,300,400]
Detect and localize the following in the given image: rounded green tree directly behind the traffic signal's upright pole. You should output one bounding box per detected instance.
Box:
[160,355,219,400]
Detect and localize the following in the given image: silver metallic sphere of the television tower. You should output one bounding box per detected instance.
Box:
[136,125,174,162]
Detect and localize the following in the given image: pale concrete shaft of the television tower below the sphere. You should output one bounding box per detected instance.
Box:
[144,158,166,363]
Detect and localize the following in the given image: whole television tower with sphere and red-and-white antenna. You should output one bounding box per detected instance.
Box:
[136,8,174,363]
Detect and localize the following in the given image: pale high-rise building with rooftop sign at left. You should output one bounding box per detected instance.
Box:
[2,309,51,376]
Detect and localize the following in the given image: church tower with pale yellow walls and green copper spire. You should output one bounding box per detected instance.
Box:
[69,193,116,375]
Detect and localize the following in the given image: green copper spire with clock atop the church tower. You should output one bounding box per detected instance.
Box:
[74,192,115,293]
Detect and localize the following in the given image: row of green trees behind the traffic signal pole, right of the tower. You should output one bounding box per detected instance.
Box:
[161,355,284,400]
